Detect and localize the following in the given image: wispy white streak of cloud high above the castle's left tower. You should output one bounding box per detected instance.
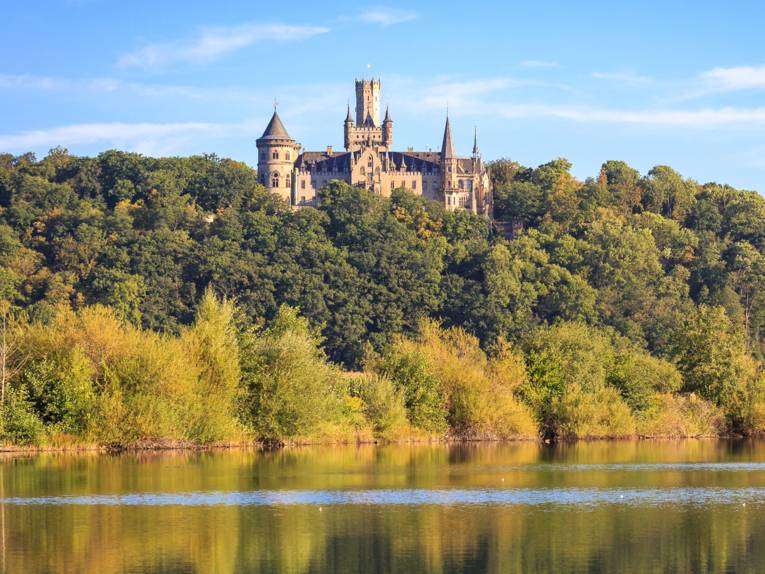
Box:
[117,24,329,68]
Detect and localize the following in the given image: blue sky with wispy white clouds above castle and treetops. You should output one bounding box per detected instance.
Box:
[0,0,765,191]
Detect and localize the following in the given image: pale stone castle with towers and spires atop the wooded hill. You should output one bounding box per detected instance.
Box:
[256,80,491,216]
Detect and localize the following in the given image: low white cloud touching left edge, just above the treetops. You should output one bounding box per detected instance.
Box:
[0,122,237,153]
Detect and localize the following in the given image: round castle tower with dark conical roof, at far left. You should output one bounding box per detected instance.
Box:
[255,108,300,205]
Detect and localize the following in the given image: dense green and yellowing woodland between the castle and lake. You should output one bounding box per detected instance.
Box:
[0,149,765,445]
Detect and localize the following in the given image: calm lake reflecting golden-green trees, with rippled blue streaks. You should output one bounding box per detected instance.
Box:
[0,440,765,573]
